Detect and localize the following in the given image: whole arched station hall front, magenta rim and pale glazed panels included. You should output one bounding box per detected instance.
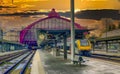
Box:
[20,9,88,46]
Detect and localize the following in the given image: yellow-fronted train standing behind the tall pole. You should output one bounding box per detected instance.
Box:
[58,38,92,56]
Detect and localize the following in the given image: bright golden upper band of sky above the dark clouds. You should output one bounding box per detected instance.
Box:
[0,0,120,13]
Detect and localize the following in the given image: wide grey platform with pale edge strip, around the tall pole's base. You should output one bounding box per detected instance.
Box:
[31,49,120,74]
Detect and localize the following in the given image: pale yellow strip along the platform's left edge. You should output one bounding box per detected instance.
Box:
[31,50,45,74]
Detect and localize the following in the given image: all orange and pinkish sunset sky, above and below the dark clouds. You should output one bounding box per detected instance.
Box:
[0,0,120,40]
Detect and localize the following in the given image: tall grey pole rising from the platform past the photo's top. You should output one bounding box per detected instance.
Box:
[70,0,75,63]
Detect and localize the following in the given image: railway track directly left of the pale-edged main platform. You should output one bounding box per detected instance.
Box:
[3,51,35,74]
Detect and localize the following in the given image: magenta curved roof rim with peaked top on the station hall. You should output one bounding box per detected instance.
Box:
[20,9,85,43]
